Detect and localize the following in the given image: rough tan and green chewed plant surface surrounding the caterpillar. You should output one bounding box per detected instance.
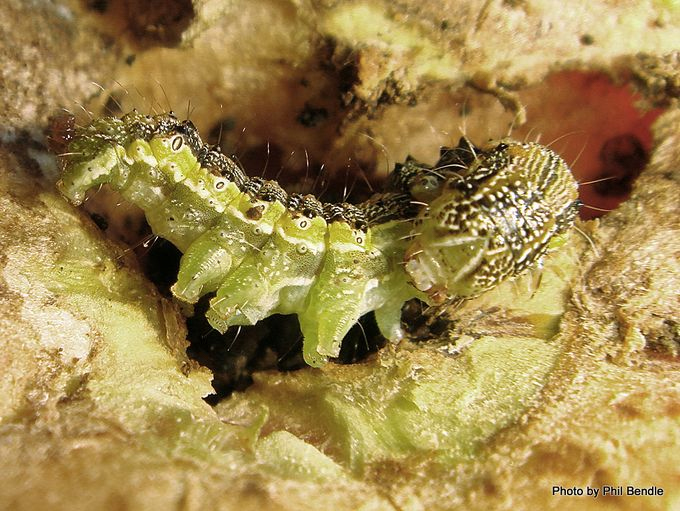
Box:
[0,0,680,509]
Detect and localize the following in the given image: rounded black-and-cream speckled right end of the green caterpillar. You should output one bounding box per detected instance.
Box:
[405,140,579,302]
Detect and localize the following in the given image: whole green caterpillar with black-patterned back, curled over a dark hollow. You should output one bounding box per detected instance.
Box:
[54,111,579,367]
